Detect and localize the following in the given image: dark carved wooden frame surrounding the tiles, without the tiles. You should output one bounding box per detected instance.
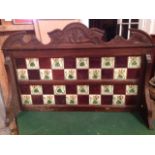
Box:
[3,23,153,128]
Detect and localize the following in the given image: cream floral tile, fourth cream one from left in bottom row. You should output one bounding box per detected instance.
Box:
[89,94,101,105]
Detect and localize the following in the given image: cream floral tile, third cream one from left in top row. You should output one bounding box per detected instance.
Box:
[76,58,89,69]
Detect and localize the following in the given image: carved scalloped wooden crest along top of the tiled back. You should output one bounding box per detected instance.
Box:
[3,23,152,50]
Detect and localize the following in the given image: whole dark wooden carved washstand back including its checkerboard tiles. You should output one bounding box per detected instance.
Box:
[3,23,153,128]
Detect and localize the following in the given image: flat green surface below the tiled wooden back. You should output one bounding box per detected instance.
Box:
[17,112,155,135]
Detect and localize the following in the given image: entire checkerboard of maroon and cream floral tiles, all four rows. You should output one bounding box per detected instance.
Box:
[16,56,142,106]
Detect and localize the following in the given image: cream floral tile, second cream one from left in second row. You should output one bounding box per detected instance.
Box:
[40,69,52,80]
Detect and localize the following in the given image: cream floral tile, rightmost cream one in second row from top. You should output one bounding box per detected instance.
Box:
[114,68,127,80]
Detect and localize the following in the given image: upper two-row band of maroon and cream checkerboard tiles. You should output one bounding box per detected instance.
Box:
[16,56,141,80]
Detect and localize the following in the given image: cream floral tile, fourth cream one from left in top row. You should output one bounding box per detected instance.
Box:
[101,57,115,69]
